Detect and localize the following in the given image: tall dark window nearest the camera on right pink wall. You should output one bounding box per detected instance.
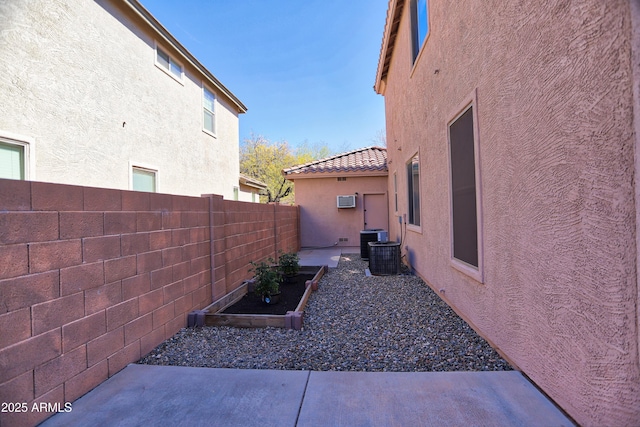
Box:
[449,107,479,269]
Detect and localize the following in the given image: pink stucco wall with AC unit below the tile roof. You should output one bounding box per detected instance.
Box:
[295,175,387,247]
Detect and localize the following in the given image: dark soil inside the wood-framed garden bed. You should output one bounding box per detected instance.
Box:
[223,273,315,315]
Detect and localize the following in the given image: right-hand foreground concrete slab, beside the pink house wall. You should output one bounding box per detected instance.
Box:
[297,371,573,427]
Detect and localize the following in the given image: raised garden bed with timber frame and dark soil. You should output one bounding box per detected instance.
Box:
[190,266,327,330]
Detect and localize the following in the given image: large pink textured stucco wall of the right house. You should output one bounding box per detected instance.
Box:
[384,0,640,425]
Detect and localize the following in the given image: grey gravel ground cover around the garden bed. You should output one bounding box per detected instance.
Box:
[138,255,512,372]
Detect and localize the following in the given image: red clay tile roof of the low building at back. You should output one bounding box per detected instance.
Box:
[282,147,388,179]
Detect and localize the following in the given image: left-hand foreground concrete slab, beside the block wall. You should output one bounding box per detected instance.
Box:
[41,365,309,427]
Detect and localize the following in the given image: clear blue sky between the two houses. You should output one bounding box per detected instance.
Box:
[140,0,387,152]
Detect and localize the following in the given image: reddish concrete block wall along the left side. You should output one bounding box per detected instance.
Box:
[0,180,298,426]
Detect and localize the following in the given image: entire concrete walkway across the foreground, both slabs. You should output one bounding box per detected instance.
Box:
[42,365,573,427]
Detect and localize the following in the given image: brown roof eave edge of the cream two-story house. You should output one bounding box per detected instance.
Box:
[124,0,247,113]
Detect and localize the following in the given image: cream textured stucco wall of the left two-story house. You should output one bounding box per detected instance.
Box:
[0,0,239,198]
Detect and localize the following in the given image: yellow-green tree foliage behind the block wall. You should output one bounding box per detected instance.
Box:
[240,135,331,203]
